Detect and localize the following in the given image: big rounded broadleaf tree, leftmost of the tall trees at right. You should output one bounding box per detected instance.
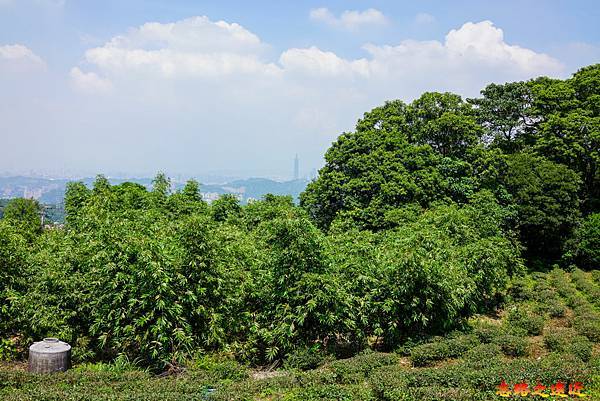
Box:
[301,93,482,229]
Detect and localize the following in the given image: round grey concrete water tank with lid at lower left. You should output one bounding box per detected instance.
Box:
[29,338,71,373]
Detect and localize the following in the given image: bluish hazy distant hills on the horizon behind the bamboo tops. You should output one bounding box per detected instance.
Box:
[0,176,308,204]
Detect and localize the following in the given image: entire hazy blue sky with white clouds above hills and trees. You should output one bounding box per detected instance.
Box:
[0,0,600,178]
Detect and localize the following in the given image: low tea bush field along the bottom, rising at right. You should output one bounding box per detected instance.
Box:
[0,270,600,401]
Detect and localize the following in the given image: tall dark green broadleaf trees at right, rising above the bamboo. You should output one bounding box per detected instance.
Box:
[301,65,600,260]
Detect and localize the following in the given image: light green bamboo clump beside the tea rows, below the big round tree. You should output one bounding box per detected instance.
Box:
[328,192,522,348]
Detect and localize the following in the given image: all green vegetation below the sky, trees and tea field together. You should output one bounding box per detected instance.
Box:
[0,65,600,400]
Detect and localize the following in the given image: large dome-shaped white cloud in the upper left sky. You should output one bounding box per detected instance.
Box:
[79,17,278,78]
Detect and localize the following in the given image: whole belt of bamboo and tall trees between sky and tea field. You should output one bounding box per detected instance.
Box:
[0,65,600,368]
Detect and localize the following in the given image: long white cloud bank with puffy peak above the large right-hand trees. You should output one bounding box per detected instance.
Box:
[280,21,563,83]
